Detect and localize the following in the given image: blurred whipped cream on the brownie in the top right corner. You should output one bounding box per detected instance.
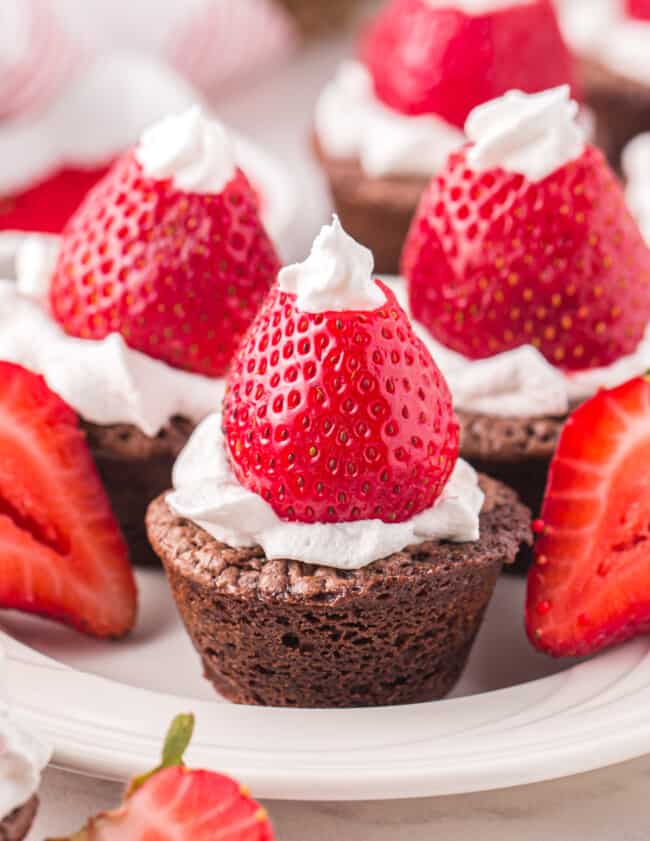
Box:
[558,0,650,84]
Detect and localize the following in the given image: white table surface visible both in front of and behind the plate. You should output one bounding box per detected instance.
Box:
[17,31,650,841]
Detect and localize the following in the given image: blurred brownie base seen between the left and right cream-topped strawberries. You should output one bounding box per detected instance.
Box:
[313,134,429,274]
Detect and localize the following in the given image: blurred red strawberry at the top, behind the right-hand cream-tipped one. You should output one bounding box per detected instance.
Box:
[361,0,579,128]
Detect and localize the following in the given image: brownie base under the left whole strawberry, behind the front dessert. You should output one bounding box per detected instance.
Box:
[82,418,193,566]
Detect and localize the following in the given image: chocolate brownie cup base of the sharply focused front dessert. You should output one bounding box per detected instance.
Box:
[147,477,531,707]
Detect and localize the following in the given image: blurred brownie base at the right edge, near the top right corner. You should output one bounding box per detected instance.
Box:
[580,59,650,170]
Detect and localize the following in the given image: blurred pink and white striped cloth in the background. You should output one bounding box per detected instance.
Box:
[0,0,297,119]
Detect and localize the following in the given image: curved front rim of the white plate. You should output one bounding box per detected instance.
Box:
[5,630,650,801]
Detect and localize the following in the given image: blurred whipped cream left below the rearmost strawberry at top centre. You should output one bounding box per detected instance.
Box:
[315,61,465,177]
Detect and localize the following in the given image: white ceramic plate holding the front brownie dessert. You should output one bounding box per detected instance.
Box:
[0,570,650,800]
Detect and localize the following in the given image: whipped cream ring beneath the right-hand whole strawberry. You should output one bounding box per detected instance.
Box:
[386,279,650,418]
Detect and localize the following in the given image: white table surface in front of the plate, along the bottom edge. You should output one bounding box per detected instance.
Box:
[28,757,650,841]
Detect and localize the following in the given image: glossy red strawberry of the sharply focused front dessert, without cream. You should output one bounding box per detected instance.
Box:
[223,284,458,523]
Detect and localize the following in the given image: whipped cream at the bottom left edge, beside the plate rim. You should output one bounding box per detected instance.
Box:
[0,649,52,821]
